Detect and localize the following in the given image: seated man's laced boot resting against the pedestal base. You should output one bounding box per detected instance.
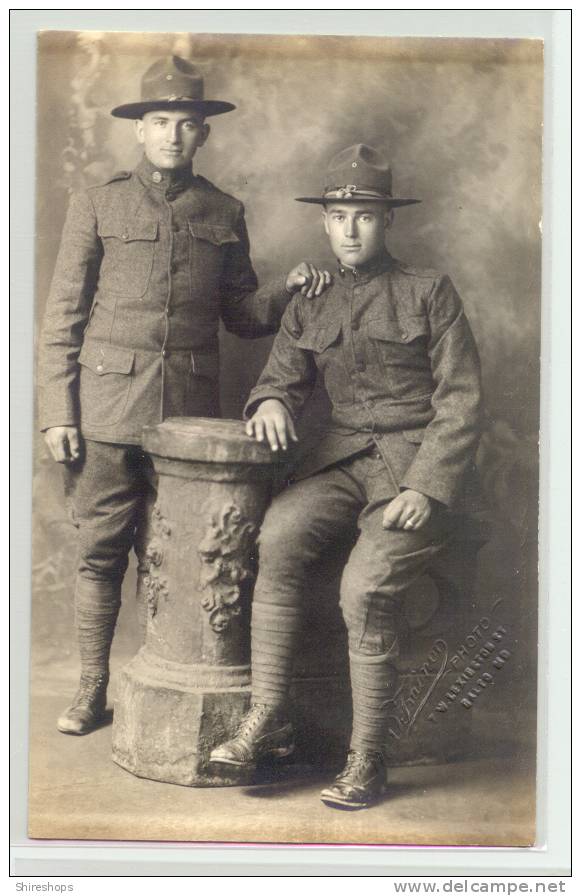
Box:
[210,703,295,769]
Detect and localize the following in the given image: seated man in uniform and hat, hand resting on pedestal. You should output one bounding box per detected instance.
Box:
[211,144,481,809]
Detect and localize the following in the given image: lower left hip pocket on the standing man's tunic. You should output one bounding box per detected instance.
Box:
[79,342,135,427]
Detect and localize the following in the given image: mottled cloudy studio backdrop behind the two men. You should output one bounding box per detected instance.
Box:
[33,32,542,720]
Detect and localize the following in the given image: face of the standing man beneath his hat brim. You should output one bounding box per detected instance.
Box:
[135,109,210,170]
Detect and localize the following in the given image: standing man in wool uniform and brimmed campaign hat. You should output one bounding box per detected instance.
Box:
[39,56,330,734]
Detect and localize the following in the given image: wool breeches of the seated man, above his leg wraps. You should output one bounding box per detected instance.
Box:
[254,454,457,659]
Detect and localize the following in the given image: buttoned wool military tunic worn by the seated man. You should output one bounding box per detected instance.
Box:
[246,253,481,510]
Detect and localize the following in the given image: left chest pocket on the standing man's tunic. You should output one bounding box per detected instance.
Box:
[99,220,158,299]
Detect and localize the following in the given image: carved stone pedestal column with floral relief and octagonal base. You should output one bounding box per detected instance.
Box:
[113,418,273,786]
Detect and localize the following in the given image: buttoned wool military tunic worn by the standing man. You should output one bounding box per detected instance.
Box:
[39,158,289,444]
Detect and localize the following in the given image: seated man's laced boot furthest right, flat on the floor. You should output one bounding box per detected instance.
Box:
[321,750,385,810]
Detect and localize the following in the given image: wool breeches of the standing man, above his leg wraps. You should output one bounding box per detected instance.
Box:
[64,440,156,583]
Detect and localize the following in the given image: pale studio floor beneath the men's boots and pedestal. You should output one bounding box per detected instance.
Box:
[29,652,535,846]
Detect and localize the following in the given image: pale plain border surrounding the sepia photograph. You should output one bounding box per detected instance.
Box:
[10,9,571,877]
